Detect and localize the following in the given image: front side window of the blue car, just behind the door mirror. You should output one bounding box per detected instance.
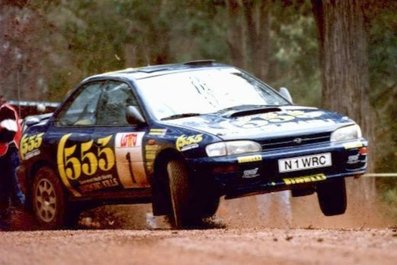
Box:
[96,81,137,126]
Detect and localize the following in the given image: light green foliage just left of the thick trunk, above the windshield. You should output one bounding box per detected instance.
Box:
[270,1,321,106]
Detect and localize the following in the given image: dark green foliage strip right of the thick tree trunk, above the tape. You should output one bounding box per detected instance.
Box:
[368,5,397,172]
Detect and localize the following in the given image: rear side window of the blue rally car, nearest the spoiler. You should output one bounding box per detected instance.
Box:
[56,82,103,126]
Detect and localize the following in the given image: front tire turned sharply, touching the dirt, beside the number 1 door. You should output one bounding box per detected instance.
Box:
[167,159,190,229]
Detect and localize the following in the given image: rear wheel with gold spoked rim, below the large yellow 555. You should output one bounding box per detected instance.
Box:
[32,167,78,230]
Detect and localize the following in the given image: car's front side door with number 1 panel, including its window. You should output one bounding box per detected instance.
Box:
[95,81,149,190]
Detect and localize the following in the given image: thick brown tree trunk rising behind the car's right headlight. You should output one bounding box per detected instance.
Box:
[312,0,375,208]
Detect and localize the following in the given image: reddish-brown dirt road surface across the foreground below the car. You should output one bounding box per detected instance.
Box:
[0,225,397,265]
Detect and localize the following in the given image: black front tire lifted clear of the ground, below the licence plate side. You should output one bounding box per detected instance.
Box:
[317,178,347,216]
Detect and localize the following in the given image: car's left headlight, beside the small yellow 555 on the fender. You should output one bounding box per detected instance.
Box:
[205,141,262,157]
